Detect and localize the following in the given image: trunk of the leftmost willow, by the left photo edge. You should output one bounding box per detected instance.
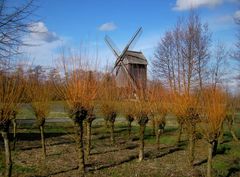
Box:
[1,121,12,177]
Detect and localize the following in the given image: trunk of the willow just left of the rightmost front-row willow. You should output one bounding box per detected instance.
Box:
[188,126,196,166]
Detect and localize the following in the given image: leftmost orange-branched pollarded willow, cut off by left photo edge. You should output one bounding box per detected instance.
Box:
[0,68,24,177]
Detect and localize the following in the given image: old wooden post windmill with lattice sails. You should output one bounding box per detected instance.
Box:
[105,28,148,92]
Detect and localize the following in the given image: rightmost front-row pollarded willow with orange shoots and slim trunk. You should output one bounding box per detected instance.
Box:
[200,85,227,177]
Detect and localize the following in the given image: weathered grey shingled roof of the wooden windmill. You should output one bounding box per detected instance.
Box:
[123,50,148,65]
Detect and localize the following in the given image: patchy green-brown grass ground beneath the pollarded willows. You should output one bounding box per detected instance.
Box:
[0,111,240,177]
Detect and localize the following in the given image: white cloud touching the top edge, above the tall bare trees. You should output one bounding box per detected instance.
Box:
[173,0,223,10]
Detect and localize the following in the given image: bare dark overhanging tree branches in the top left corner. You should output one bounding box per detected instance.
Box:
[0,0,36,60]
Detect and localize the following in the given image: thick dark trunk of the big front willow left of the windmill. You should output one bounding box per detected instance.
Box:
[75,120,85,177]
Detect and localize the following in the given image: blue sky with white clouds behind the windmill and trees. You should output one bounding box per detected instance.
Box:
[16,0,240,66]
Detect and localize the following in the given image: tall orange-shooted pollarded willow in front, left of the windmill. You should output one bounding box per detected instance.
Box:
[55,50,98,176]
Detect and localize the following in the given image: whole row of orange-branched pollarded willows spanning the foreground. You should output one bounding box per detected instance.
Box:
[0,57,237,176]
